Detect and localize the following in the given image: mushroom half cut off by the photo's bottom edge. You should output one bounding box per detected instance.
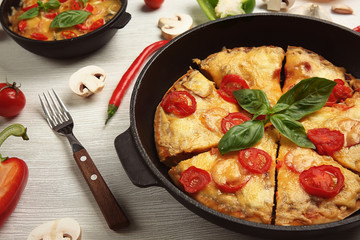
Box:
[27,218,81,240]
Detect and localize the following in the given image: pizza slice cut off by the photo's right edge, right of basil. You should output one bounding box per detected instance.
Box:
[301,92,360,173]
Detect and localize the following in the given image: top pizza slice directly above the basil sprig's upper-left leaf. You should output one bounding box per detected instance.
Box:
[194,46,285,106]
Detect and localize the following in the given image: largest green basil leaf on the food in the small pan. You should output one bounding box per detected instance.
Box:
[50,10,91,28]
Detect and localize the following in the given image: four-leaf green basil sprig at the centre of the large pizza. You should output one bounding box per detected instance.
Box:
[218,77,336,154]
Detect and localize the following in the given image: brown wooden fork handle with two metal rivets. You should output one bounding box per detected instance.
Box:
[74,149,129,230]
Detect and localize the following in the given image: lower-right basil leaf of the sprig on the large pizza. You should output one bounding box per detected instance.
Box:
[270,114,315,149]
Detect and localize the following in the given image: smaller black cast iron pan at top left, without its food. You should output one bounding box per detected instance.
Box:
[0,0,131,58]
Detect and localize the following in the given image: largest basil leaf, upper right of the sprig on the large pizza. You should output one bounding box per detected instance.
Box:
[274,77,336,120]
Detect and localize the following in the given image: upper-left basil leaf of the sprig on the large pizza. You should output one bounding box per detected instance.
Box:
[233,89,271,118]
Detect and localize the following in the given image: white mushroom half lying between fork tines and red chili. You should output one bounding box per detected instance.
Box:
[69,65,106,97]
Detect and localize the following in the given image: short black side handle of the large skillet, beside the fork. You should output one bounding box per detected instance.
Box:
[114,128,160,187]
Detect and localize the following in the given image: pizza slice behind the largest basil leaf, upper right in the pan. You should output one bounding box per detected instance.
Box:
[282,46,348,93]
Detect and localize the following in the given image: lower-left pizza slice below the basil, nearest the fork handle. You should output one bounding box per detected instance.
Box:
[169,127,278,224]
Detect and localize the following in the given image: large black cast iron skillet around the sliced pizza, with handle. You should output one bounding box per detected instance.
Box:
[115,13,360,238]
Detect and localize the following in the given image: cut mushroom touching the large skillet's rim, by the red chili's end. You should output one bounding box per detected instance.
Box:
[158,14,193,40]
